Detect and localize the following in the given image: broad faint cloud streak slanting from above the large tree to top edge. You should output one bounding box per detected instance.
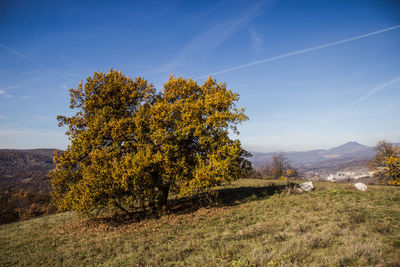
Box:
[159,1,269,72]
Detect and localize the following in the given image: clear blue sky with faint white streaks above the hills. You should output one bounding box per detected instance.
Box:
[0,0,400,151]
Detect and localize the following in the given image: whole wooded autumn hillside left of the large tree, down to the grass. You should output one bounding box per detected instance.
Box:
[0,149,55,223]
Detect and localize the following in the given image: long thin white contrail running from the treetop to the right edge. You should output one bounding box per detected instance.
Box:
[195,25,400,80]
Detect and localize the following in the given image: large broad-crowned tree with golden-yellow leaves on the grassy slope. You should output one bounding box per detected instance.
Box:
[50,70,250,217]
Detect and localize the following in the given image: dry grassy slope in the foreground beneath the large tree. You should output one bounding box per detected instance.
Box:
[0,179,400,266]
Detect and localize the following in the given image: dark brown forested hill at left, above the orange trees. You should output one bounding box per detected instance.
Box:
[0,149,56,191]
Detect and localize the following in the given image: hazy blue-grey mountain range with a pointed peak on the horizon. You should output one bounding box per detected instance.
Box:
[250,142,376,168]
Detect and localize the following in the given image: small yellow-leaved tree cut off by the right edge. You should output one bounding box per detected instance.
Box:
[370,141,400,185]
